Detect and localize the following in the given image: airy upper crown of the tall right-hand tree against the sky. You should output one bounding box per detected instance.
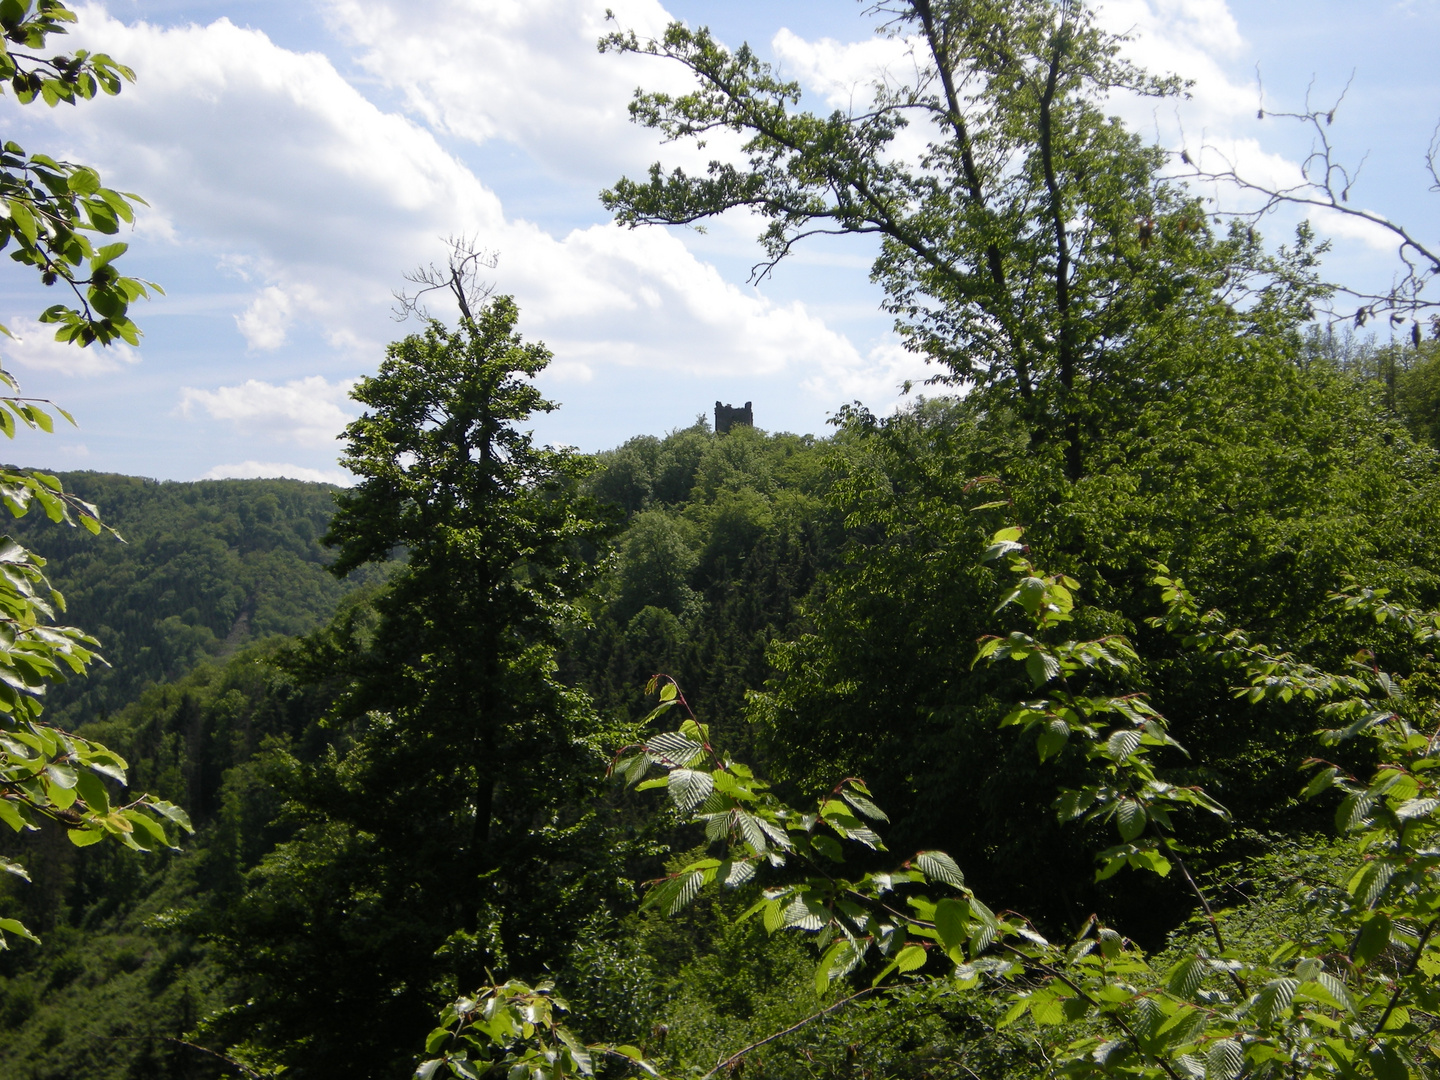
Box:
[600,0,1313,481]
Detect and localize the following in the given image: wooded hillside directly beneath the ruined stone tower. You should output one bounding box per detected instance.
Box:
[560,423,840,746]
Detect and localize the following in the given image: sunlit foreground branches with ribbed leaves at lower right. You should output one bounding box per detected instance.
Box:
[411,515,1440,1080]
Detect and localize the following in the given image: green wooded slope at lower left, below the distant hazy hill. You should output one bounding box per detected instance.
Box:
[0,639,327,1080]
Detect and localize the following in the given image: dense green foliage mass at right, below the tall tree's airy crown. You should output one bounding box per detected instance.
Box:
[749,357,1440,945]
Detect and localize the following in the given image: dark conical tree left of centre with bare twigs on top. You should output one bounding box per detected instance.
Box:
[226,297,624,1077]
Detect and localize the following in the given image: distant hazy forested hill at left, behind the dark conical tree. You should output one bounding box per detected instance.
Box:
[4,472,383,724]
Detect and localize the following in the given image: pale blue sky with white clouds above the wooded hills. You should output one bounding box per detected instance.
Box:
[0,0,1440,482]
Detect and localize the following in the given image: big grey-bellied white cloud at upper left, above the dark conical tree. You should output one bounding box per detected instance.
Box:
[59,7,503,356]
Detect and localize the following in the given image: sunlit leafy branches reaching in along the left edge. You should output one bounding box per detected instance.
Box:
[0,0,190,948]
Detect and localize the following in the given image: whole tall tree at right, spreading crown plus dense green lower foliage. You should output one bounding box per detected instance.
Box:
[602,0,1437,933]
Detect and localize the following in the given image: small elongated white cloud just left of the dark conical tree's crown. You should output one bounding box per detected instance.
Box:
[179,374,356,449]
